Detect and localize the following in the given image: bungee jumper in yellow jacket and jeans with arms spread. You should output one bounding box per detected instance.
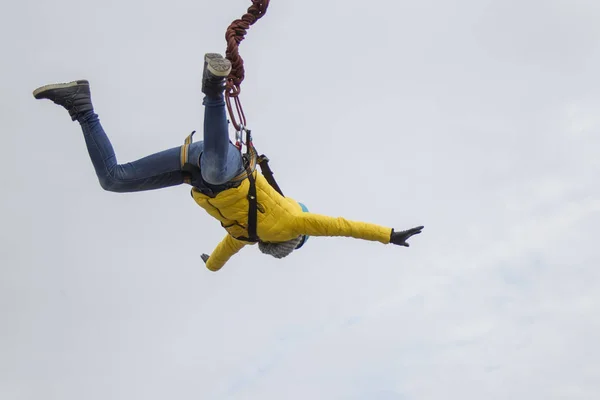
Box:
[33,53,424,271]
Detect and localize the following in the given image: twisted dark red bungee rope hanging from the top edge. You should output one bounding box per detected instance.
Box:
[225,0,269,131]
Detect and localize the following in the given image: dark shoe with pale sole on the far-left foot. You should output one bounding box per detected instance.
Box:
[33,79,94,121]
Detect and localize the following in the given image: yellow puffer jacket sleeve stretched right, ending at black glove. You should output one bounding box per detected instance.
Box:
[296,213,392,244]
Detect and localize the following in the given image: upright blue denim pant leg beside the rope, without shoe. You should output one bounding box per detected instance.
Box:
[200,95,244,185]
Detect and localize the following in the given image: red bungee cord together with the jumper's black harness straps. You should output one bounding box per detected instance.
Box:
[181,0,283,243]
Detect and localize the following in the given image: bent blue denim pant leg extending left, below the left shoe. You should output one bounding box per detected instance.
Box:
[79,111,184,193]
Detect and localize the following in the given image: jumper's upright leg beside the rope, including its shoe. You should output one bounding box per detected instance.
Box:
[200,53,244,185]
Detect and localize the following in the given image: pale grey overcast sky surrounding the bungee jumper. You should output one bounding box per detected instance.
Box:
[0,0,600,400]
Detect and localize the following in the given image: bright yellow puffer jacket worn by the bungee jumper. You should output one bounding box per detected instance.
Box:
[192,171,392,271]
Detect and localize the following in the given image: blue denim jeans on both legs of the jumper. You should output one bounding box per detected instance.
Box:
[79,96,244,194]
